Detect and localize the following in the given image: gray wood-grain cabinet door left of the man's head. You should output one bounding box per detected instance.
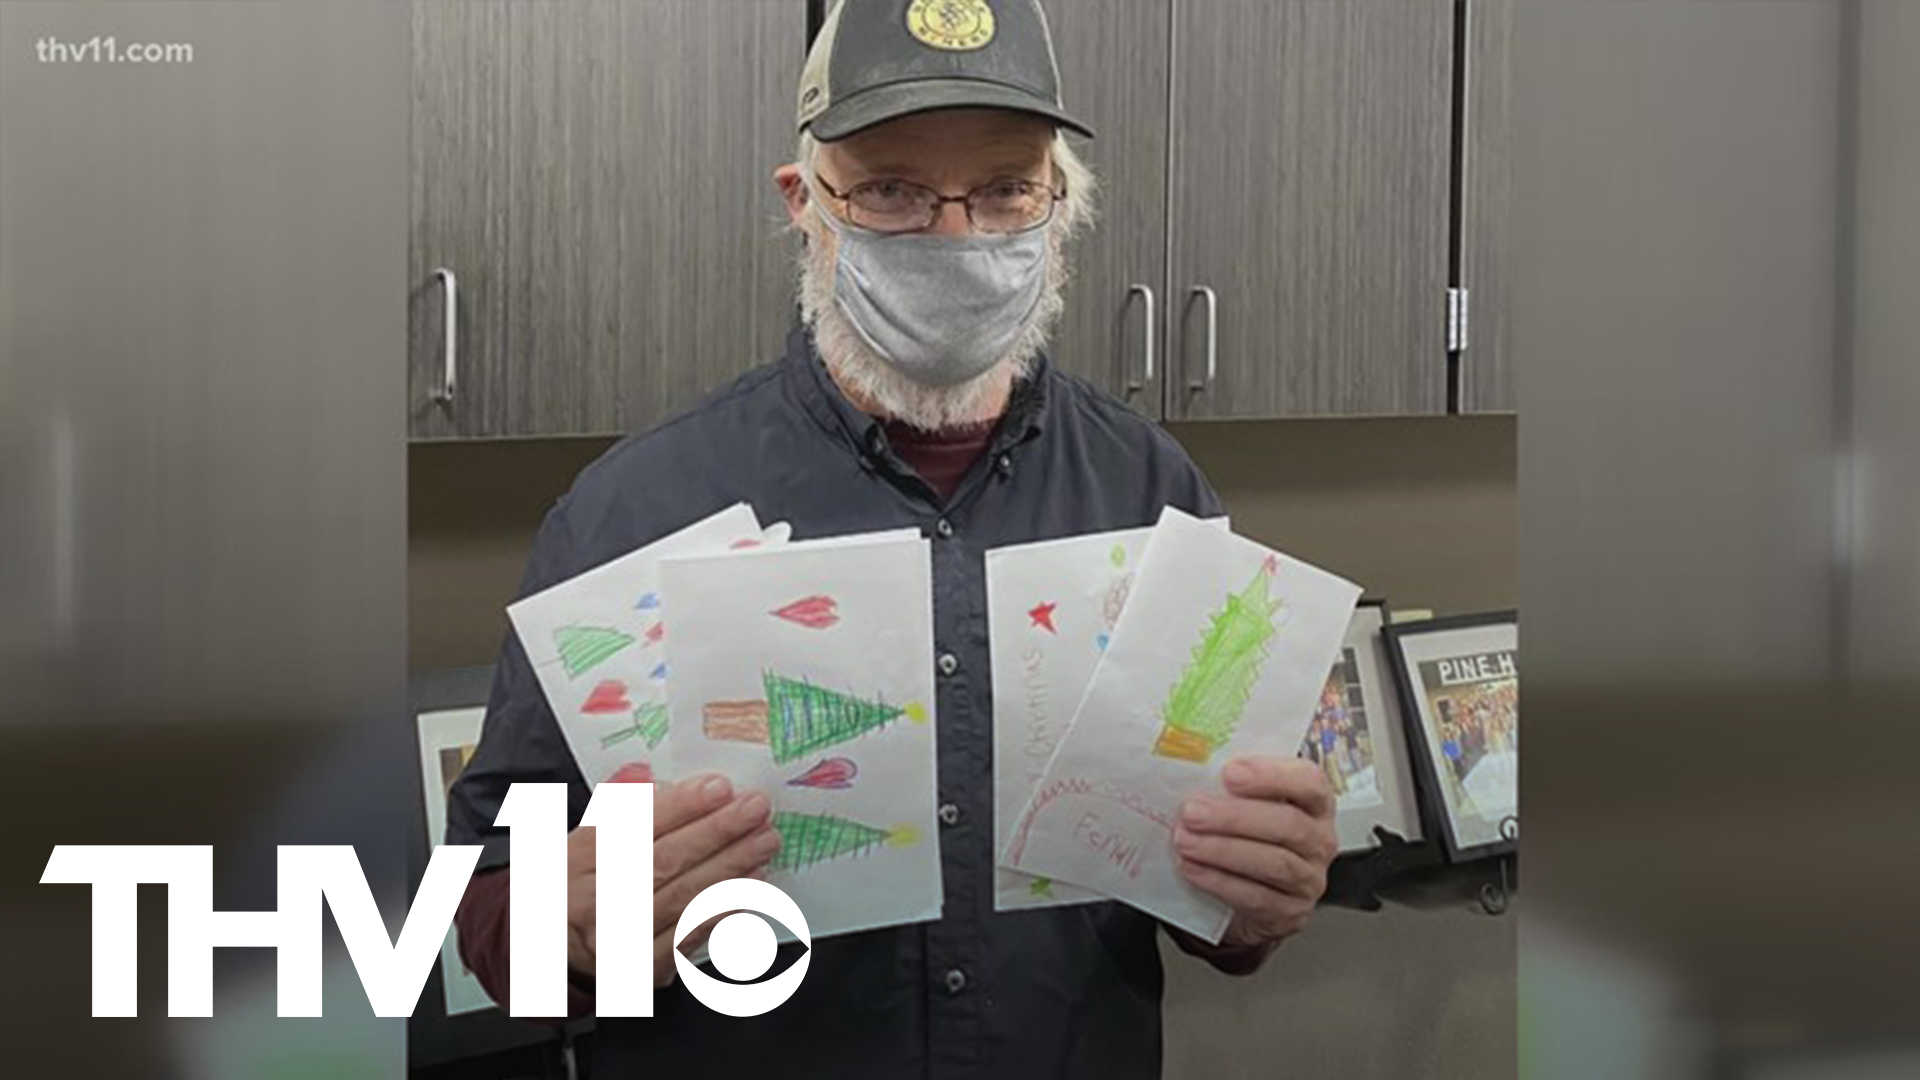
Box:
[409,0,806,440]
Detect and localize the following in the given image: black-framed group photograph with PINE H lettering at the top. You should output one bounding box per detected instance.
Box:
[1382,611,1521,863]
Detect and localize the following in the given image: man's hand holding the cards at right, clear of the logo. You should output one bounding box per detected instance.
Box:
[1173,757,1340,945]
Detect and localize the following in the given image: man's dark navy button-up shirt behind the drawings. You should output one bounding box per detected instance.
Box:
[447,331,1221,1080]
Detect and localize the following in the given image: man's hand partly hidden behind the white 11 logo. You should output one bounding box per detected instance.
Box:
[566,765,780,986]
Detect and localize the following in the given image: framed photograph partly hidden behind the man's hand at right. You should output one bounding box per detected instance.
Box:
[1300,600,1425,855]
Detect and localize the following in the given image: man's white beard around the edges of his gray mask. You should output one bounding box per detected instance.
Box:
[799,206,1068,430]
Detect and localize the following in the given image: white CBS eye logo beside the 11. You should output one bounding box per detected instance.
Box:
[674,878,814,1017]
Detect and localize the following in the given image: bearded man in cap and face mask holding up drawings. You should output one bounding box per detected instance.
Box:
[449,0,1336,1080]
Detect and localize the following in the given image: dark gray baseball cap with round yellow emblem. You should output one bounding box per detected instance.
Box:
[799,0,1092,142]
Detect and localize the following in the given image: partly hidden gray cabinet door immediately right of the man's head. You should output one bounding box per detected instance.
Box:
[1046,0,1173,419]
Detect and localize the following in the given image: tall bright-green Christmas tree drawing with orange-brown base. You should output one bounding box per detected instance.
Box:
[1154,567,1281,765]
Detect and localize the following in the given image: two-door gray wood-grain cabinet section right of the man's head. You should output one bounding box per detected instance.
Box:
[1048,0,1466,419]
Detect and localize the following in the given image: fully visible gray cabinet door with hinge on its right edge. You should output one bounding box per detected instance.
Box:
[1167,0,1453,417]
